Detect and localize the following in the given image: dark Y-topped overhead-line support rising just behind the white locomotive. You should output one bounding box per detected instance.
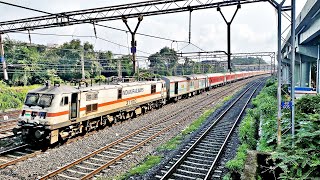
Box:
[122,16,143,76]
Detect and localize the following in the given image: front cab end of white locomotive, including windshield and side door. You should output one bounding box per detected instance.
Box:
[13,85,78,144]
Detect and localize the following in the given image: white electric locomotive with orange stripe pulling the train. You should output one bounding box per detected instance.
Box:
[14,81,167,144]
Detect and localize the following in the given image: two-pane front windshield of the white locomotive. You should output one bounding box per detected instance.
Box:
[25,93,53,107]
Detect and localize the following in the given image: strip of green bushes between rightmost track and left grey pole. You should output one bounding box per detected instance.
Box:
[226,79,277,179]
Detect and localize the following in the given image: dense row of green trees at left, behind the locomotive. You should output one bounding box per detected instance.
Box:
[0,39,117,85]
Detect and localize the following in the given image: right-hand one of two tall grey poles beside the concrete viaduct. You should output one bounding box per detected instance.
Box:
[291,0,296,146]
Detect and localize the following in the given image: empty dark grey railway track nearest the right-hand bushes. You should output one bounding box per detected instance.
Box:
[156,79,261,180]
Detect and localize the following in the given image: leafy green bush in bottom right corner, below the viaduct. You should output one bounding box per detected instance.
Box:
[273,95,320,179]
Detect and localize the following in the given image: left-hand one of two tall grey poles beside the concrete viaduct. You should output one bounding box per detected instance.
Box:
[277,5,282,146]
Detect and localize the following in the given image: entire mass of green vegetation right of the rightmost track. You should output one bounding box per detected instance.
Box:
[226,79,320,179]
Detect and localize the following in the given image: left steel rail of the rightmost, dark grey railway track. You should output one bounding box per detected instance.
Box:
[161,79,262,180]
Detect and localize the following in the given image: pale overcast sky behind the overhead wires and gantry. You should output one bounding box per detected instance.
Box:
[0,0,307,63]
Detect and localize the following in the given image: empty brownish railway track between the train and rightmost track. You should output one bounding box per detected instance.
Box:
[40,77,262,179]
